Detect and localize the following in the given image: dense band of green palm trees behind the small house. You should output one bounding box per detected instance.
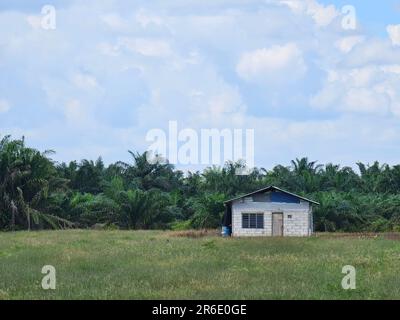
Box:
[0,136,400,231]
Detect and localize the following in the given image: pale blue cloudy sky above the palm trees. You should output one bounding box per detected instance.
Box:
[0,0,400,170]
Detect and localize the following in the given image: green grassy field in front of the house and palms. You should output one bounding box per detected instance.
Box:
[0,230,400,299]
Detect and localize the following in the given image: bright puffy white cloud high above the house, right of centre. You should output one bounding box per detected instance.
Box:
[236,43,307,83]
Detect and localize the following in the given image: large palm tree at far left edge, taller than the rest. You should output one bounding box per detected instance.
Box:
[0,136,70,230]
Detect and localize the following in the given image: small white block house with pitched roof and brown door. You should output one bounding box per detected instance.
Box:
[223,186,319,237]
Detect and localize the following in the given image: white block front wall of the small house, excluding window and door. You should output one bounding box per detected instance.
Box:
[232,197,312,236]
